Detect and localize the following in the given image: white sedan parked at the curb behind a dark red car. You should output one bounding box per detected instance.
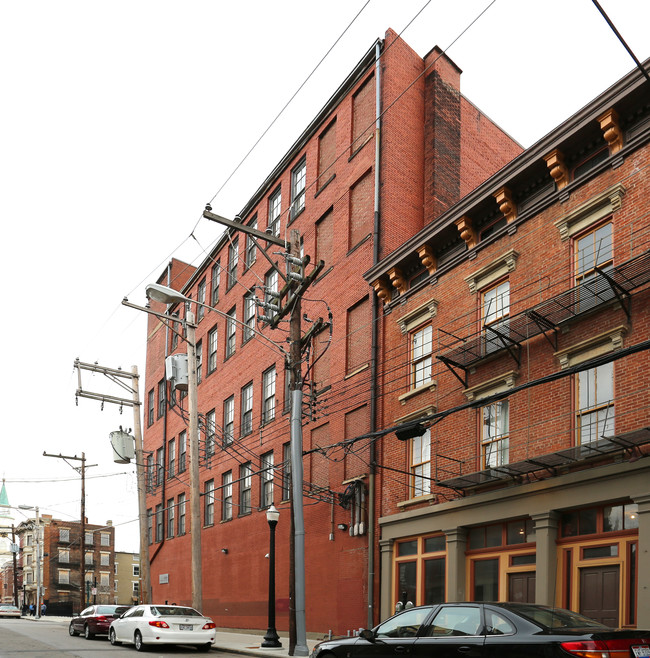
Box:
[108,605,216,651]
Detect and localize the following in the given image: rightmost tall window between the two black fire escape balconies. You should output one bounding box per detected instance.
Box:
[576,362,614,445]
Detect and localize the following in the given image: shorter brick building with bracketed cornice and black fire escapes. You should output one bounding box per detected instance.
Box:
[368,63,650,628]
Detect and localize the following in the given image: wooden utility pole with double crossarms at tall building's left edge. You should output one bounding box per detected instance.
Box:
[74,359,151,603]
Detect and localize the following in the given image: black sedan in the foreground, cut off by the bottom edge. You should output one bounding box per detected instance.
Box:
[311,603,650,658]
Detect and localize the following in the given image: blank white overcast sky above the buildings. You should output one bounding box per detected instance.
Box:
[0,0,650,551]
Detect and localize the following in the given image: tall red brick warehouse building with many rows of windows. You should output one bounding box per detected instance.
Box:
[144,31,521,633]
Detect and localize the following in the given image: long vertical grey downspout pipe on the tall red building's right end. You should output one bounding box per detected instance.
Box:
[368,42,382,628]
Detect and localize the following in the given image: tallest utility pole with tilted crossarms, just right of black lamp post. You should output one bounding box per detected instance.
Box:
[203,209,324,656]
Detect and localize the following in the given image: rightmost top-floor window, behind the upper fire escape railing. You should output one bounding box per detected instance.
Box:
[574,222,614,311]
